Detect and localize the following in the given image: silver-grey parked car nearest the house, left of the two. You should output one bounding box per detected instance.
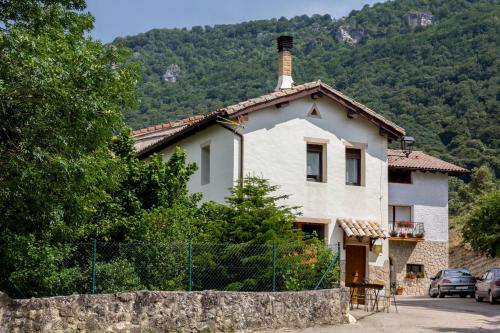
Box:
[429,268,476,298]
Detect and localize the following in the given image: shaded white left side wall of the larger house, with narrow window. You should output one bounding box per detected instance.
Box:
[161,125,239,203]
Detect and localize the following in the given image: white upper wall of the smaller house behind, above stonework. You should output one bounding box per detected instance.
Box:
[389,171,448,242]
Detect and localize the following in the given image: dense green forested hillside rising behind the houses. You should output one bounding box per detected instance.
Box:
[118,0,500,177]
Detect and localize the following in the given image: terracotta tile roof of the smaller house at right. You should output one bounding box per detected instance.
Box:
[387,149,469,173]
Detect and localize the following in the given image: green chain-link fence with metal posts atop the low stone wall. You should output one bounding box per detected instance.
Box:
[4,241,340,297]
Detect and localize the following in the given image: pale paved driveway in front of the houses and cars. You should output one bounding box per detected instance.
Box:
[262,297,500,333]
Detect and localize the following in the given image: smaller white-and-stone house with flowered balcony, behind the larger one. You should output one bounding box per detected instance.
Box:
[388,150,467,295]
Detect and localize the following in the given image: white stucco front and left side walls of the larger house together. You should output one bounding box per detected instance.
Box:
[158,96,388,272]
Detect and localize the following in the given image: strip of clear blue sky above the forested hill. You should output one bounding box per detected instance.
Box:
[87,0,383,43]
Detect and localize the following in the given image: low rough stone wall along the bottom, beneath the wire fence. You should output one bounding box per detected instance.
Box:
[0,288,349,333]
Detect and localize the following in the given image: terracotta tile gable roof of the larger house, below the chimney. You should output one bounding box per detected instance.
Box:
[133,81,405,157]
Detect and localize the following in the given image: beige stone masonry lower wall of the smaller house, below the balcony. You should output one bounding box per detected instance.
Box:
[389,241,448,296]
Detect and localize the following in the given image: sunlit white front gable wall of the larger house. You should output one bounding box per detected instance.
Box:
[244,97,388,265]
